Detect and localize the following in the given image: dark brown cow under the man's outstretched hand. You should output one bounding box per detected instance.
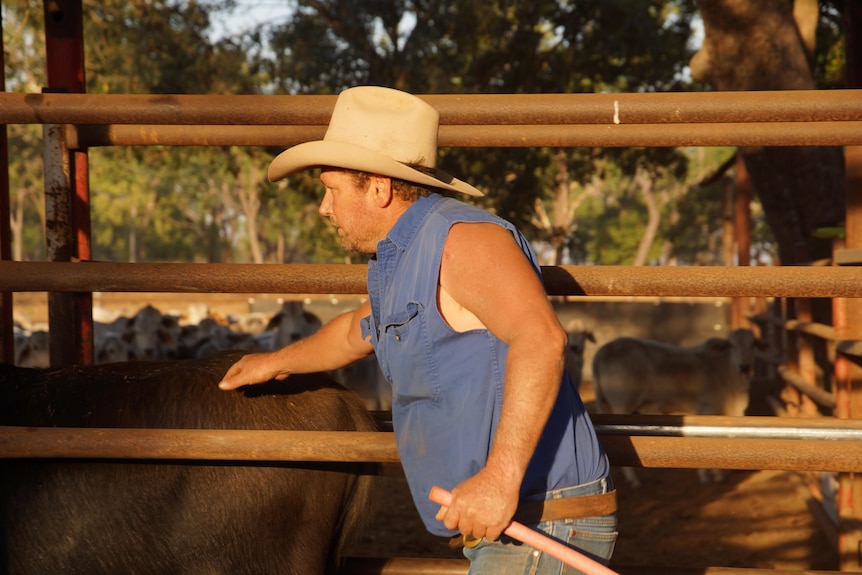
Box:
[0,352,377,575]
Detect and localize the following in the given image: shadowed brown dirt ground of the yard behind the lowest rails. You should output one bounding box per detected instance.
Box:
[350,382,838,571]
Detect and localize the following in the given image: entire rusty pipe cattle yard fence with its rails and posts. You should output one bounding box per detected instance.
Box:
[0,90,862,575]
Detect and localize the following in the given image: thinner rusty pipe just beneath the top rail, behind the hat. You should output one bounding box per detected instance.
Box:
[66,121,862,149]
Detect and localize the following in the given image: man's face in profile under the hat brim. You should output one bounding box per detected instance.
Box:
[318,169,381,254]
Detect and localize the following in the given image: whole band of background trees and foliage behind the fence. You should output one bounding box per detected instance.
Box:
[3,0,842,264]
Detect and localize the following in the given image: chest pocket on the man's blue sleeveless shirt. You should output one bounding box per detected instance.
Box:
[377,302,439,404]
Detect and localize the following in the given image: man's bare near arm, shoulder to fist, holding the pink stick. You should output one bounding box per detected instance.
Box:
[438,224,566,539]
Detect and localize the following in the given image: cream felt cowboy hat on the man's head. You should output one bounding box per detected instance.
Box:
[268,86,484,196]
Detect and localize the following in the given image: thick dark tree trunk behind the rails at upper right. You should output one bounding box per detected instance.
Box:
[691,0,845,264]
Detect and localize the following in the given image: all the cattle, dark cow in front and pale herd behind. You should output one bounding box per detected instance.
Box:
[0,303,759,574]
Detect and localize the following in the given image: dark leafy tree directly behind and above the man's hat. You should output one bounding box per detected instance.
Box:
[261,0,695,261]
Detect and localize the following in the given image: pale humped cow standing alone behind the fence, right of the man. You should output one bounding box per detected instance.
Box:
[593,329,759,485]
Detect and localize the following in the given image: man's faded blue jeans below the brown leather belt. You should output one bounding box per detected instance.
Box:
[464,477,617,575]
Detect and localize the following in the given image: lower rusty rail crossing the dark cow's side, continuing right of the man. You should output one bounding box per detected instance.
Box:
[5,415,862,472]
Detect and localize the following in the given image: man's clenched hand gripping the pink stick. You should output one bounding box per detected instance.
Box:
[436,468,518,541]
